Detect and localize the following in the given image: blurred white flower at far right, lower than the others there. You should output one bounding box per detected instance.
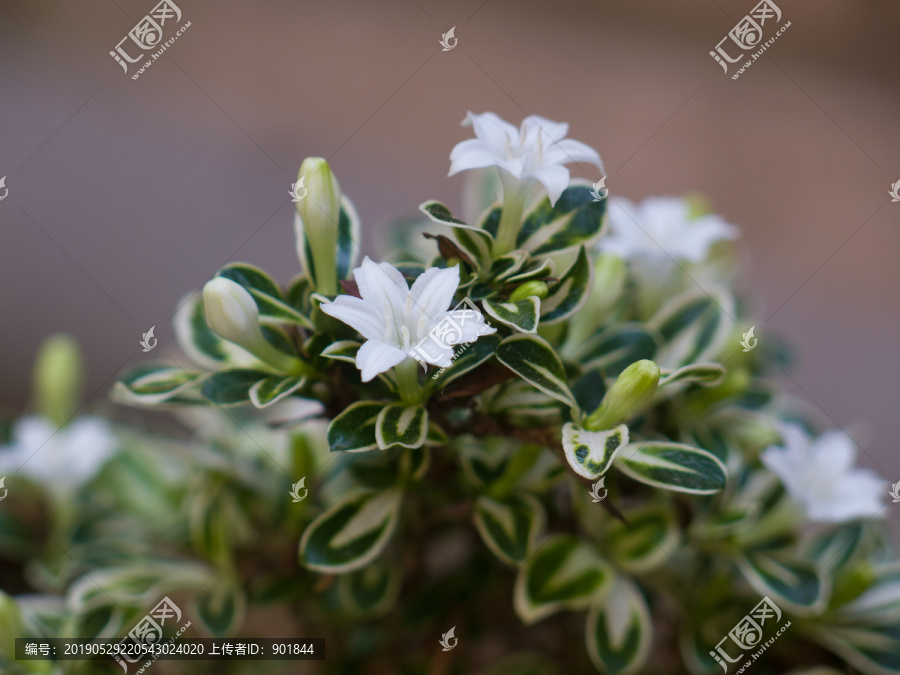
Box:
[761,425,887,523]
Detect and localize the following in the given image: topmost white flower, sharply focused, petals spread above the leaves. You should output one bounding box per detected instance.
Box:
[448,112,603,204]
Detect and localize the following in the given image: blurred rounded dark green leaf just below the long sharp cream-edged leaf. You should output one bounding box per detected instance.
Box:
[603,504,681,574]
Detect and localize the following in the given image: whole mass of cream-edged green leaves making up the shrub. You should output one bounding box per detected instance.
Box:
[0,165,900,675]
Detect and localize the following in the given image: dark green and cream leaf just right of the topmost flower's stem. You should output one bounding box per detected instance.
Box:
[516,180,606,256]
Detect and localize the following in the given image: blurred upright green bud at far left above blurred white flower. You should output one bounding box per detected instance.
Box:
[33,335,82,427]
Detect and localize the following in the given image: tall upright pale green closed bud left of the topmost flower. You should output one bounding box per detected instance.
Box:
[294,157,341,295]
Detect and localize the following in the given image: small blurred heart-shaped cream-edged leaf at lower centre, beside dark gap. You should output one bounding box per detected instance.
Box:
[473,493,546,566]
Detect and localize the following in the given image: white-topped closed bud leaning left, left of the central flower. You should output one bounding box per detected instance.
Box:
[203,277,303,373]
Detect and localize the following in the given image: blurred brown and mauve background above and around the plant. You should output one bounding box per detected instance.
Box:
[0,0,900,544]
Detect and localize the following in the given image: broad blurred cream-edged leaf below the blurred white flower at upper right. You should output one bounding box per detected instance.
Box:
[649,290,735,369]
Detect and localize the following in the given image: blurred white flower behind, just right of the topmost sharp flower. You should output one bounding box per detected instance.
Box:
[600,197,739,267]
